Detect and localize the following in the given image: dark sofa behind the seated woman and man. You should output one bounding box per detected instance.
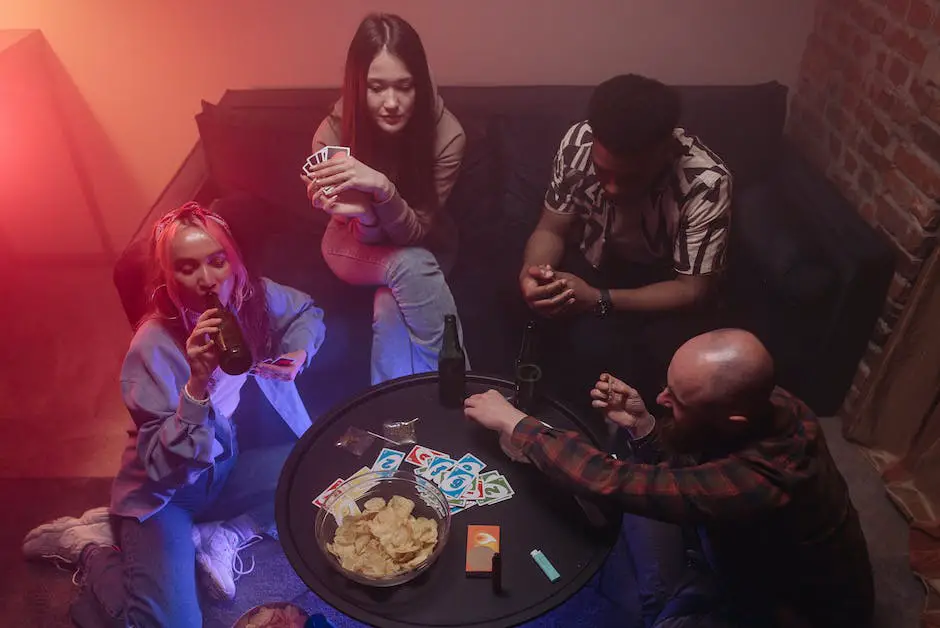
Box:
[115,83,893,416]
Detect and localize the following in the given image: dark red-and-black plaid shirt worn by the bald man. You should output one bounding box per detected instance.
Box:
[512,388,874,628]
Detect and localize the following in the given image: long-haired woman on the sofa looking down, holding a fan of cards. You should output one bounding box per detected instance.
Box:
[303,14,466,384]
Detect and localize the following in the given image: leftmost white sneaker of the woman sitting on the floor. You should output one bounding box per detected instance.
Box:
[23,508,115,564]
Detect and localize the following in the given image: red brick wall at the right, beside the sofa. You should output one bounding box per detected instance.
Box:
[787,0,940,416]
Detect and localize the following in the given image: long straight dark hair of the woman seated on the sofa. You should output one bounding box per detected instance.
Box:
[343,13,437,206]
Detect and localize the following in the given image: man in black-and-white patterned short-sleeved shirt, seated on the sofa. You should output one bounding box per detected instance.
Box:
[519,75,731,418]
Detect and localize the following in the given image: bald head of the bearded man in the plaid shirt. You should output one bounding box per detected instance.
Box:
[669,329,774,415]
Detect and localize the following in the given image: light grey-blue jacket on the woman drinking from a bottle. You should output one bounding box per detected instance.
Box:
[111,279,326,521]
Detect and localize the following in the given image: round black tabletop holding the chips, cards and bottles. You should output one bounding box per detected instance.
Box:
[276,373,619,628]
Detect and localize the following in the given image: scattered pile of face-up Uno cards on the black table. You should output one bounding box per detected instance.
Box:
[313,445,515,515]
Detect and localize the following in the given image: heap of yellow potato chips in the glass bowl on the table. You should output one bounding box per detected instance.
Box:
[327,495,438,578]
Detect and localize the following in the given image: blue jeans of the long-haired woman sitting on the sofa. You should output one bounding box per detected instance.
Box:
[321,220,470,385]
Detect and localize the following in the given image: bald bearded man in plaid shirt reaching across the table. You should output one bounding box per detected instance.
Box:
[465,330,874,628]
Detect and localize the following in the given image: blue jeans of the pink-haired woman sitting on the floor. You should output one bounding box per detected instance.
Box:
[71,444,293,628]
